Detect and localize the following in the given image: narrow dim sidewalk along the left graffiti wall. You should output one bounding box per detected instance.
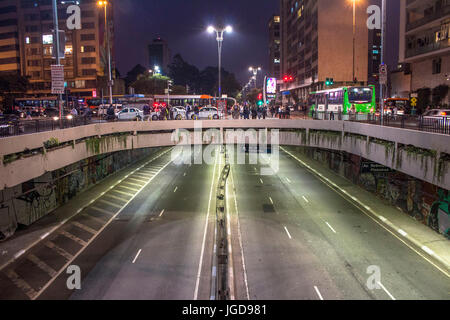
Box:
[0,150,163,270]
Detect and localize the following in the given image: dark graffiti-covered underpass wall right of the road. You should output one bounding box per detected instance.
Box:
[299,148,450,238]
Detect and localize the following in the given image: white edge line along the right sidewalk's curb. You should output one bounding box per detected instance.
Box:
[280,147,450,278]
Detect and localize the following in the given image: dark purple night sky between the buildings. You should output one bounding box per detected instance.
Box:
[115,0,399,84]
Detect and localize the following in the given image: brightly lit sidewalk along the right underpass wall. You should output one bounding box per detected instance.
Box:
[282,148,450,277]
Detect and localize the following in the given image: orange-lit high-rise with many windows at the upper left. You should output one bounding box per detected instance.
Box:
[0,0,118,96]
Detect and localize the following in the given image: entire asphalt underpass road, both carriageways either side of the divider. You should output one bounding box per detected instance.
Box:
[0,145,450,300]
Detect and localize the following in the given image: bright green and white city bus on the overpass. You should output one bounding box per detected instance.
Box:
[310,85,377,115]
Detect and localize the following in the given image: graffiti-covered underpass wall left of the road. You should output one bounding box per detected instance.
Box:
[0,149,158,241]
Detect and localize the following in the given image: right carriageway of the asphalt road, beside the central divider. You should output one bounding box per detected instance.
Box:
[231,151,450,300]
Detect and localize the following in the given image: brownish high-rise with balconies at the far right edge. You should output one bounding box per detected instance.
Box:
[400,0,450,104]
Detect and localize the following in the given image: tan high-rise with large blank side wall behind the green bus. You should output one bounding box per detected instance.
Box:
[281,0,369,100]
